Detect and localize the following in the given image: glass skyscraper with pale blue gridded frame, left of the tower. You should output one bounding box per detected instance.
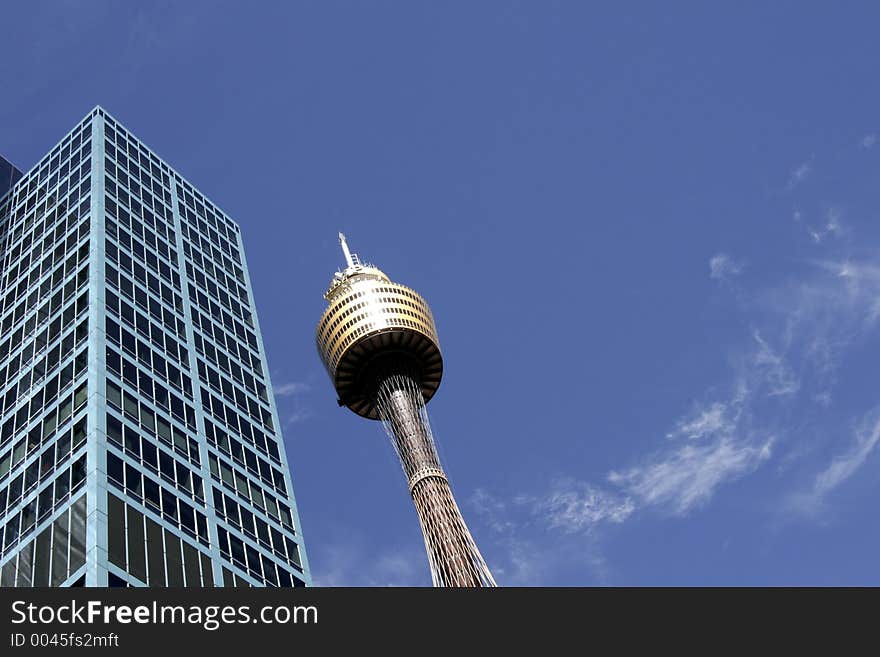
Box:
[0,107,311,586]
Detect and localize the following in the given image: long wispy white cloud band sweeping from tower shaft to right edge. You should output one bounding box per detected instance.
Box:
[470,247,880,585]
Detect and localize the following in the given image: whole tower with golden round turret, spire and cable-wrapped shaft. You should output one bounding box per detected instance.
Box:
[316,233,496,586]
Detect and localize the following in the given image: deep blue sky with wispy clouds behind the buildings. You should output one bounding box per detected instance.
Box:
[0,1,880,585]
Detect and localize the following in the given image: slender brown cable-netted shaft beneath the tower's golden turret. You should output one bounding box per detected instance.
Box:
[376,373,496,587]
